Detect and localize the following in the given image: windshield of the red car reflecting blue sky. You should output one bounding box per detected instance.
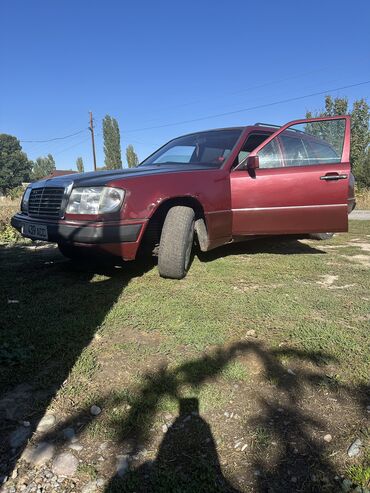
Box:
[140,129,242,168]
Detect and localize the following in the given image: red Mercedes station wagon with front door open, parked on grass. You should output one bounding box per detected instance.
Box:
[12,116,355,279]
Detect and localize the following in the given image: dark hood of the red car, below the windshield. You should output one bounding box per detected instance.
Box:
[31,164,215,188]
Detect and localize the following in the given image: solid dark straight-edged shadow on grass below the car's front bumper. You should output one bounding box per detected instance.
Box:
[0,245,151,477]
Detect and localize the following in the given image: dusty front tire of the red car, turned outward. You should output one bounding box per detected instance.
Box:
[158,206,195,279]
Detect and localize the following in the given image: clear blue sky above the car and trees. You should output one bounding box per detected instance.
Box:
[0,0,370,170]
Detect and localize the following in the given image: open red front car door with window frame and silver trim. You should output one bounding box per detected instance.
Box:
[230,116,354,235]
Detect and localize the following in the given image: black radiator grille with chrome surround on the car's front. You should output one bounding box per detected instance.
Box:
[28,187,64,218]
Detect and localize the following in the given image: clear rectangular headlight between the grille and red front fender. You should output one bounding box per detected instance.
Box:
[67,187,125,214]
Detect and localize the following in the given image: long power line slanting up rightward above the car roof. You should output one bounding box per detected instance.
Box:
[125,80,370,133]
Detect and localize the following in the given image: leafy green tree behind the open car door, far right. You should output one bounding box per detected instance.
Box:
[306,96,370,187]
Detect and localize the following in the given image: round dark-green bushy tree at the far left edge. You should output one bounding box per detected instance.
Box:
[0,134,33,193]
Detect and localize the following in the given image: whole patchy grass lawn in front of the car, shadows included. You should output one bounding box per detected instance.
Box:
[0,221,370,493]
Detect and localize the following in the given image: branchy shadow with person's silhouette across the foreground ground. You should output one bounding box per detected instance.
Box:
[30,340,367,493]
